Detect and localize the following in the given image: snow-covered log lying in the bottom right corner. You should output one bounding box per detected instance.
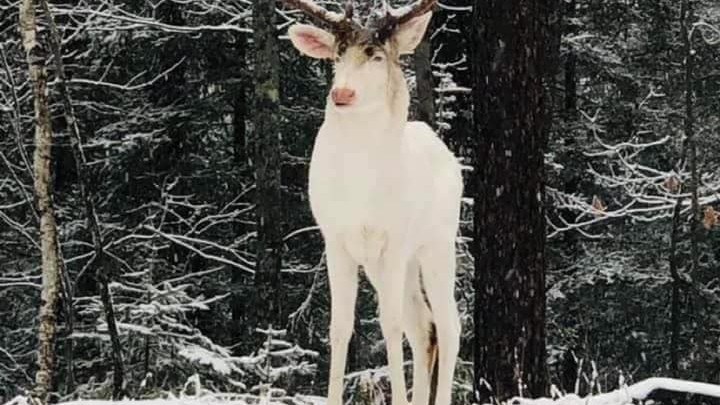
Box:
[508,378,720,405]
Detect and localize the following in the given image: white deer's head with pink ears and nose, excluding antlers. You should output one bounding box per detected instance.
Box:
[288,13,431,111]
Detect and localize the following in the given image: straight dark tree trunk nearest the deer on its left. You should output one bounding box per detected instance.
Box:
[253,0,282,327]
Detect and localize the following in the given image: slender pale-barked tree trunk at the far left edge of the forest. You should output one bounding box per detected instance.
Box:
[19,0,60,403]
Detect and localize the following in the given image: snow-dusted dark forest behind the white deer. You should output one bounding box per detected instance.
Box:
[0,0,720,405]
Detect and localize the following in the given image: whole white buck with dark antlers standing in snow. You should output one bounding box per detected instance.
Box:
[286,0,463,405]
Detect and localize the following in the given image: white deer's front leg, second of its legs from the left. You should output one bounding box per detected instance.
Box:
[376,257,410,405]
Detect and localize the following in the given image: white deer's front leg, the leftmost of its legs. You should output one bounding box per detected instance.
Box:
[326,242,358,405]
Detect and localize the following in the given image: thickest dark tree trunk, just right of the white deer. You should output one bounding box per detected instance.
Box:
[470,0,555,403]
